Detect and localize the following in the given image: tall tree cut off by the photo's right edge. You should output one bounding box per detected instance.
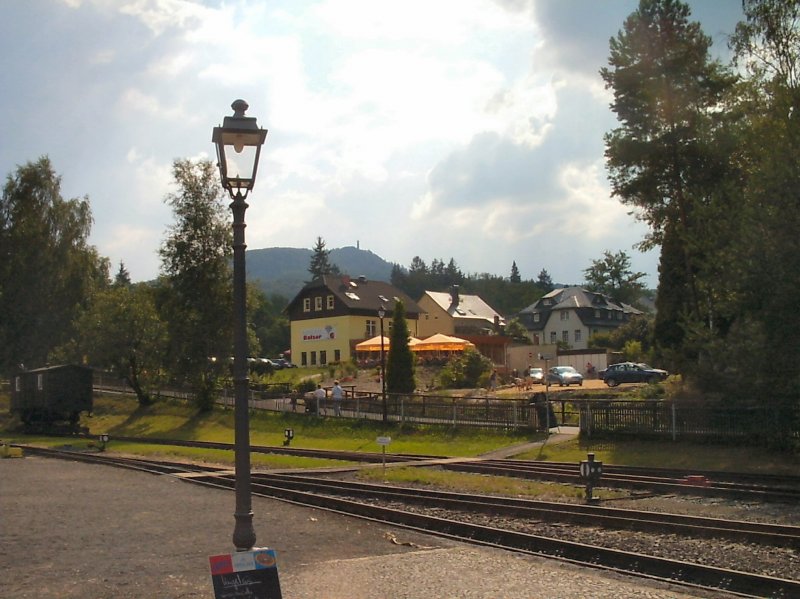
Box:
[724,0,800,408]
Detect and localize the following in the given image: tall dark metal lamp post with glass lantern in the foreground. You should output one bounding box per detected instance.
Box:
[211,100,267,551]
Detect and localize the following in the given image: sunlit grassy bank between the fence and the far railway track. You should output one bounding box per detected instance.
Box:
[0,393,800,484]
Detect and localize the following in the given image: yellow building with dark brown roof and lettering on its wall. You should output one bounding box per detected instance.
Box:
[286,275,420,366]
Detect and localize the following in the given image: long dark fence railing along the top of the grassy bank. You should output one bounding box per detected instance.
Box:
[90,372,800,440]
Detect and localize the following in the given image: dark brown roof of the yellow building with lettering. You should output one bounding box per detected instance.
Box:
[287,275,421,315]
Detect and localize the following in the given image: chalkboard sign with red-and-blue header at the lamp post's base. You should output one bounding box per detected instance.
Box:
[208,549,282,599]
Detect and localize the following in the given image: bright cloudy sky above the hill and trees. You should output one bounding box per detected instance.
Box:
[0,0,741,287]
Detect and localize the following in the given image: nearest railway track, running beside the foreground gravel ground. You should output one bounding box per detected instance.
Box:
[15,447,800,597]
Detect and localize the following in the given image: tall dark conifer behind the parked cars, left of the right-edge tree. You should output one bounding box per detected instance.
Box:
[601,0,737,366]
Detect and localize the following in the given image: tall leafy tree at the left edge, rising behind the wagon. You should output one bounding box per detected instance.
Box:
[0,157,108,372]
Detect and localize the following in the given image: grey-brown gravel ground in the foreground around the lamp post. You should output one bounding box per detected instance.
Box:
[0,458,730,599]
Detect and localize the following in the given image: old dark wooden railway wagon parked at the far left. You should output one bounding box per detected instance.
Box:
[11,364,92,425]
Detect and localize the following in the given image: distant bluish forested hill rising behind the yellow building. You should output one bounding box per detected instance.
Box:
[247,246,392,300]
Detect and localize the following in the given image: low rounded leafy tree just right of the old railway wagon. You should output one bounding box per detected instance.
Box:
[72,283,167,406]
